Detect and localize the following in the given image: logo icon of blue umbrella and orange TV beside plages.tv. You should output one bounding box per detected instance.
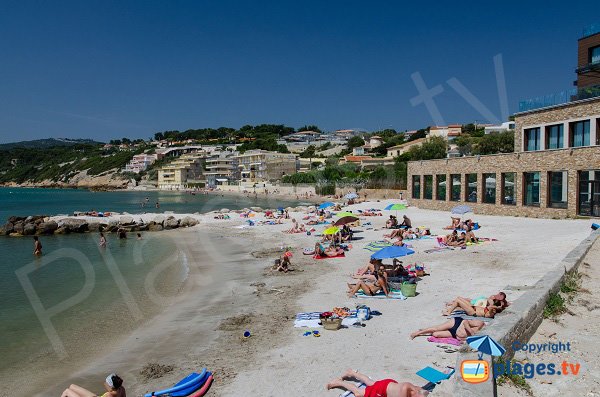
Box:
[460,335,506,383]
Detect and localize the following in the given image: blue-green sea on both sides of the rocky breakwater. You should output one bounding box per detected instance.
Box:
[0,188,300,386]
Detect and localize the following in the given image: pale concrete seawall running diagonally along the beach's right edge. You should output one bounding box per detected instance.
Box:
[453,227,600,397]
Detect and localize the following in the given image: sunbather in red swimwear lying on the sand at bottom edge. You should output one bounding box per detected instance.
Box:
[325,369,429,397]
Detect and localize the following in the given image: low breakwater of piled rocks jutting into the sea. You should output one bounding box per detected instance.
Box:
[0,215,199,237]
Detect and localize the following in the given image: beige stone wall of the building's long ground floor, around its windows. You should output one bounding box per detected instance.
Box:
[406,146,600,218]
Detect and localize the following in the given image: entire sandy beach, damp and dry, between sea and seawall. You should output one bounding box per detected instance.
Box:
[19,200,589,396]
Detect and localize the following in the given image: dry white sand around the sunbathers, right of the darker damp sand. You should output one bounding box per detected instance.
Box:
[222,201,590,396]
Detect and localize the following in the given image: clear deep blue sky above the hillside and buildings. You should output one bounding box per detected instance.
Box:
[0,0,600,142]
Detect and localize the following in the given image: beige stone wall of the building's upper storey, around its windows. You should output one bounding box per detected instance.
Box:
[515,98,600,152]
